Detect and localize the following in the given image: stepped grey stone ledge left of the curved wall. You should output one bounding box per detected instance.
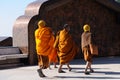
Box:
[0,47,28,69]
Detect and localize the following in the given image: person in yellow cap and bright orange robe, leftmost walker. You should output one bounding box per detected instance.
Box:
[35,20,53,77]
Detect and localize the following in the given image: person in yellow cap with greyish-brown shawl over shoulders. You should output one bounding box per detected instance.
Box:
[81,24,94,74]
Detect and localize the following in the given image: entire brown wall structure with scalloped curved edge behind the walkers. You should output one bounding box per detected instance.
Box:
[13,0,120,64]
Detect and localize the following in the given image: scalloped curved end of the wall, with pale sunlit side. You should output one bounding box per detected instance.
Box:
[13,0,47,64]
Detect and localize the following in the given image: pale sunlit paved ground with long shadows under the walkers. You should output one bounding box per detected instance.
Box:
[0,57,120,80]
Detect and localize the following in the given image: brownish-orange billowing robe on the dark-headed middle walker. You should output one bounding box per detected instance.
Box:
[58,30,78,64]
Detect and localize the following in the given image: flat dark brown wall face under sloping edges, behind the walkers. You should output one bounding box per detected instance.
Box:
[42,0,120,56]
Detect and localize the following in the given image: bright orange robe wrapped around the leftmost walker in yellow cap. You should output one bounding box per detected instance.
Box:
[35,27,53,56]
